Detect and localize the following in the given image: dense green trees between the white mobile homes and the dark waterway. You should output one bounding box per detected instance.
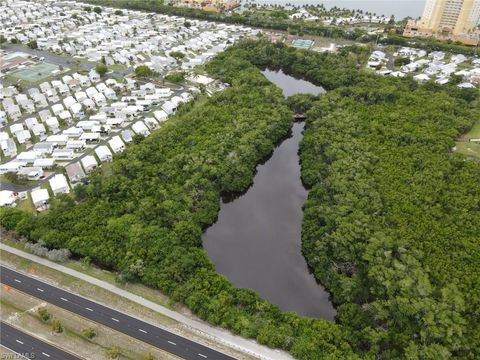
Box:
[1,46,352,359]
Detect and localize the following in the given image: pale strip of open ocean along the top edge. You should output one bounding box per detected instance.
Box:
[249,0,426,20]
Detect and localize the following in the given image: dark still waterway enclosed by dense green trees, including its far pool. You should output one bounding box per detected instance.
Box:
[203,70,335,320]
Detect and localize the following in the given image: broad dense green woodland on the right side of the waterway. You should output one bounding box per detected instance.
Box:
[219,44,480,359]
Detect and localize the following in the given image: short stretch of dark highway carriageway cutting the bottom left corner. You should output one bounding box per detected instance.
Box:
[0,321,80,360]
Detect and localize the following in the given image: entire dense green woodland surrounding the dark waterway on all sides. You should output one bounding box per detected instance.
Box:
[1,41,480,360]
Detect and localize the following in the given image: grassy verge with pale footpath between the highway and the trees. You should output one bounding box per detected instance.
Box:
[0,239,262,359]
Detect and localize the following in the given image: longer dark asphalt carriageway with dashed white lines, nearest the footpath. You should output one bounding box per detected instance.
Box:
[0,266,234,360]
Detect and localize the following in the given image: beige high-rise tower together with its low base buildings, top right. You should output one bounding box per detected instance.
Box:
[403,0,480,45]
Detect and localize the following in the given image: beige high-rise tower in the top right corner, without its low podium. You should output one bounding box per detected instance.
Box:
[419,0,480,35]
